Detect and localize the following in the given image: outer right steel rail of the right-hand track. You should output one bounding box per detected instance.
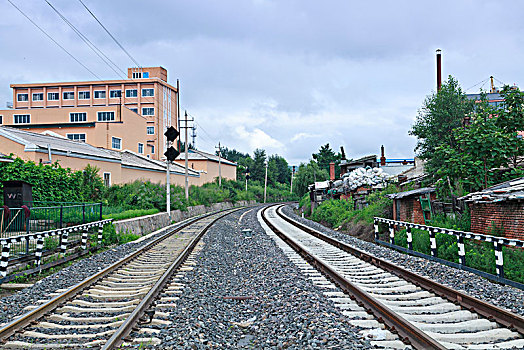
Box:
[277,206,524,335]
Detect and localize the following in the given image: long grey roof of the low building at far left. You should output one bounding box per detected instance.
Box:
[0,126,120,161]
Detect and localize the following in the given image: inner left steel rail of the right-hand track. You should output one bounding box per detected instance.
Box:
[262,205,446,350]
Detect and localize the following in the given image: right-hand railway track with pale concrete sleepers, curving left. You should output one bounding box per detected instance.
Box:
[260,206,524,349]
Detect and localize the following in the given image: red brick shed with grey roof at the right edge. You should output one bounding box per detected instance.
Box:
[460,177,524,239]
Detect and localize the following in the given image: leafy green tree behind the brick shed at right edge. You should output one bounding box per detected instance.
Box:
[426,87,524,195]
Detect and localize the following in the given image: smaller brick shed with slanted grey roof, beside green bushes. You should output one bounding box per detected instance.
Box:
[387,187,436,225]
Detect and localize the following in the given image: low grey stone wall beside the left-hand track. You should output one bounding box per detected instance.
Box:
[113,201,255,236]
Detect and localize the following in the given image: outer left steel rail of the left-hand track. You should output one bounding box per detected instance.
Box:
[0,206,242,343]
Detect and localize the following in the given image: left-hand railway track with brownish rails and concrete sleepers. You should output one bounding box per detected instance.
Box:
[0,209,239,349]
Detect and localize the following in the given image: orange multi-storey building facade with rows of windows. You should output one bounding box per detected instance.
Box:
[0,67,178,159]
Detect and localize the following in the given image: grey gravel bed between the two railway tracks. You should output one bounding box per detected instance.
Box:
[148,209,370,349]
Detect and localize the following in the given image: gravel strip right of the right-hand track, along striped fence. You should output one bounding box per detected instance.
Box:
[283,206,524,316]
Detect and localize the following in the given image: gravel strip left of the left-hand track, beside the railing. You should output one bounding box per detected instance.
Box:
[0,219,194,323]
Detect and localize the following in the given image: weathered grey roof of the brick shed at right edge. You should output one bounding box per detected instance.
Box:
[459,177,524,203]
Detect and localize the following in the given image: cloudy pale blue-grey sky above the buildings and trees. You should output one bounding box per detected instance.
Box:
[0,0,524,164]
